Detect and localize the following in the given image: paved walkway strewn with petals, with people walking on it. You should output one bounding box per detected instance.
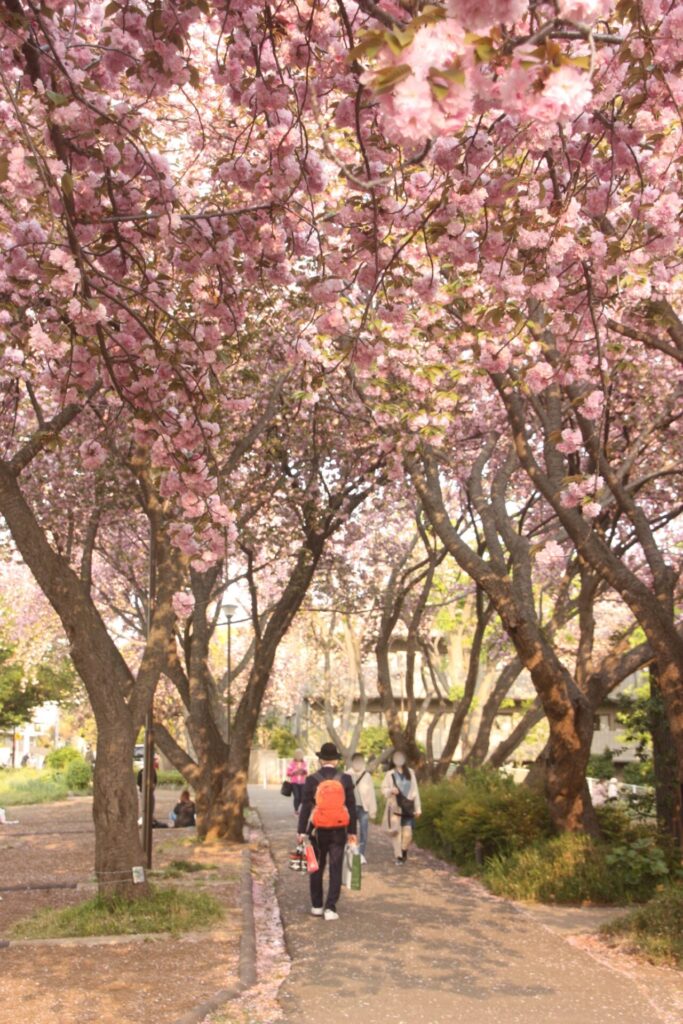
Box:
[251,787,683,1024]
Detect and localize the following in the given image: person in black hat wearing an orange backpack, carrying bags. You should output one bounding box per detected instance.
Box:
[299,743,356,921]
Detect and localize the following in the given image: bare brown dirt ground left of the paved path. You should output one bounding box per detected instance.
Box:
[0,791,242,1024]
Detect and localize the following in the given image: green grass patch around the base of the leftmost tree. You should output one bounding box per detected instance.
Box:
[9,889,224,939]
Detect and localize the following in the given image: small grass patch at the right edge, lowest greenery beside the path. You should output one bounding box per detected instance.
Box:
[600,883,683,968]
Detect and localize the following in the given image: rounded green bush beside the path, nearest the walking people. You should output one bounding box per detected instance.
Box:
[415,769,552,870]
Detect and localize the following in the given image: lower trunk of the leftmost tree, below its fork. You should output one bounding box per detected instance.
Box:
[92,723,148,899]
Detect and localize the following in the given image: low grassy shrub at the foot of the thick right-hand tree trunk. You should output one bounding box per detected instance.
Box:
[484,833,668,903]
